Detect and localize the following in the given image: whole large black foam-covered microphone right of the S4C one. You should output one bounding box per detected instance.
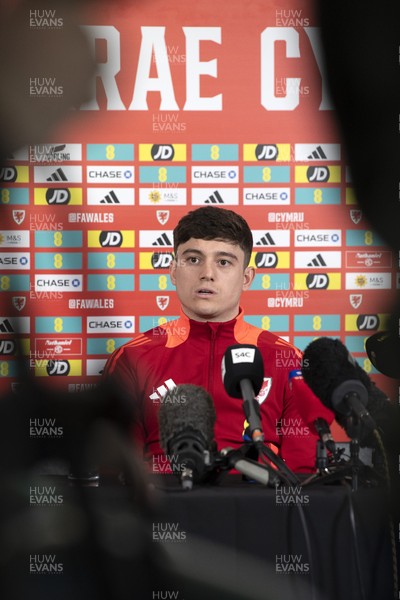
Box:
[302,337,376,437]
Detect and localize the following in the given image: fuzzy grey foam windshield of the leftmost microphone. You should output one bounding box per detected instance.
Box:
[158,383,216,452]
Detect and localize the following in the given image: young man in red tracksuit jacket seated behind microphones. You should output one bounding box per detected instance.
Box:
[105,207,326,472]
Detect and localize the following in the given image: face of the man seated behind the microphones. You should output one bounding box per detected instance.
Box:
[170,238,254,321]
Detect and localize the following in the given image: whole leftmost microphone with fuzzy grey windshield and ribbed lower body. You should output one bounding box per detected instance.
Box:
[158,384,216,490]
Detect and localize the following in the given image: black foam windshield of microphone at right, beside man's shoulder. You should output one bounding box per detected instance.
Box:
[302,337,371,409]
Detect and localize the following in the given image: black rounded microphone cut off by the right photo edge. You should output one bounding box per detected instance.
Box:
[365,331,400,379]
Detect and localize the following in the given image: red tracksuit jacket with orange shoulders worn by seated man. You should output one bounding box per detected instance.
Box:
[104,311,317,472]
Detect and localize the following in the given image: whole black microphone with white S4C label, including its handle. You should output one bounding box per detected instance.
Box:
[222,344,264,442]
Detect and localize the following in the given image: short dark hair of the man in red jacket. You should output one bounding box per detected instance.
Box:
[174,206,253,267]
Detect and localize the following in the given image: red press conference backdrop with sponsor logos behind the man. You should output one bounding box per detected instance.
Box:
[0,0,399,414]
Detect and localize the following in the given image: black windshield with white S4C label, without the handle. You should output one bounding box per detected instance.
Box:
[222,344,264,398]
